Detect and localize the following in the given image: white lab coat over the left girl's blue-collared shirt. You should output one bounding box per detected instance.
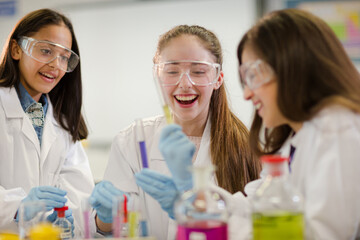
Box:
[0,88,94,237]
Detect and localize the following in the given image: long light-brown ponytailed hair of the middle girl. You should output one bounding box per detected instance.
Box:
[154,25,261,193]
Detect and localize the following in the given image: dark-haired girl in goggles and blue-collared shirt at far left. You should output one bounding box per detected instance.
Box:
[0,9,93,238]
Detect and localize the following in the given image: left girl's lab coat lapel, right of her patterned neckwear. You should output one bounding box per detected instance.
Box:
[40,100,58,166]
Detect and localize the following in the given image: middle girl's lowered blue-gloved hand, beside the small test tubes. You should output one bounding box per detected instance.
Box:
[89,181,129,223]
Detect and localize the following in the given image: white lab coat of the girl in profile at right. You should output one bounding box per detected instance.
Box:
[230,106,360,240]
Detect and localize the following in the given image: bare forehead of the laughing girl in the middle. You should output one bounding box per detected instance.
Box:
[159,35,216,62]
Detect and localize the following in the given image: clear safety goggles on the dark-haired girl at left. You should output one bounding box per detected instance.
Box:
[18,37,80,72]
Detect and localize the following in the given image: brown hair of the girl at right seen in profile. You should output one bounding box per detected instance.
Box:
[238,9,360,155]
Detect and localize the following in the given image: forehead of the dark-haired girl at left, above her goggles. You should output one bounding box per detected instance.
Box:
[30,23,72,49]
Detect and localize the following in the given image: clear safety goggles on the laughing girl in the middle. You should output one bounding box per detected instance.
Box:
[153,60,221,86]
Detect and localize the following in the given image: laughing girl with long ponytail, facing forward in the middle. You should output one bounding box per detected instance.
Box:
[92,25,261,240]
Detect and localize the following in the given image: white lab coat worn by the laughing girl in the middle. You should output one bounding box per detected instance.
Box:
[104,116,216,240]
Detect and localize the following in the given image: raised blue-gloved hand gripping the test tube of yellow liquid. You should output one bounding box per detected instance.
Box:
[159,124,195,191]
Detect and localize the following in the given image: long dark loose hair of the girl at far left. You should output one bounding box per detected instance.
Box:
[0,9,88,142]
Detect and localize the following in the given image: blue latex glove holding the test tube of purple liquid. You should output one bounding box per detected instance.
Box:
[135,168,180,219]
